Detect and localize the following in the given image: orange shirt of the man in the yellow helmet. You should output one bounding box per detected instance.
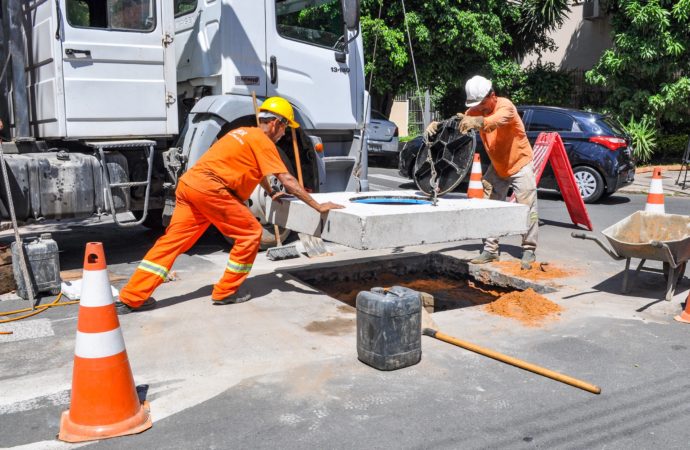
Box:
[180,127,288,201]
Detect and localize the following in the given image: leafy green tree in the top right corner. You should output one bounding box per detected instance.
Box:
[587,0,690,128]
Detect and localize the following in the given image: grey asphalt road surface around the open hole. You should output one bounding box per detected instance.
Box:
[0,162,690,449]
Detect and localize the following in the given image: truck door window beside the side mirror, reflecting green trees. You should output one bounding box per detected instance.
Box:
[276,0,345,50]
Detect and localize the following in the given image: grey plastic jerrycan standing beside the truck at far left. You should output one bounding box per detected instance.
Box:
[12,233,61,299]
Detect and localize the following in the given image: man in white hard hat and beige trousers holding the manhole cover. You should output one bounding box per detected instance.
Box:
[427,75,539,270]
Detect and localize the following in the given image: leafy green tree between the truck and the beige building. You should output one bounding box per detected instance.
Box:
[362,0,569,114]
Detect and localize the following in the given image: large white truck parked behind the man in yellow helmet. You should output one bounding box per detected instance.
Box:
[0,0,368,246]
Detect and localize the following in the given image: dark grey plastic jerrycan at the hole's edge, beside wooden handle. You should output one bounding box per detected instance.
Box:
[357,286,422,370]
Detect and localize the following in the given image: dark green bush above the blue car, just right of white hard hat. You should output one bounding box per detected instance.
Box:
[512,63,573,106]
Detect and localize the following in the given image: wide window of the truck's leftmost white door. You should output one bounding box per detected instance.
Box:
[66,0,156,32]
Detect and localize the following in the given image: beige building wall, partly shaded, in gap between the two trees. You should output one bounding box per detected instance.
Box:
[522,3,613,70]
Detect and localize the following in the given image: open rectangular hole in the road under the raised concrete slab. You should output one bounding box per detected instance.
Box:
[288,253,554,312]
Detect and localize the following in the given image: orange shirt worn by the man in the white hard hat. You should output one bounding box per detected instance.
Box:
[466,97,533,178]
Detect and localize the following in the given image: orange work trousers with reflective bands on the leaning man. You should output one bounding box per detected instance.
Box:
[120,182,262,308]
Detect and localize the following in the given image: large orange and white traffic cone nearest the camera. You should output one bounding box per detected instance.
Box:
[58,242,151,442]
